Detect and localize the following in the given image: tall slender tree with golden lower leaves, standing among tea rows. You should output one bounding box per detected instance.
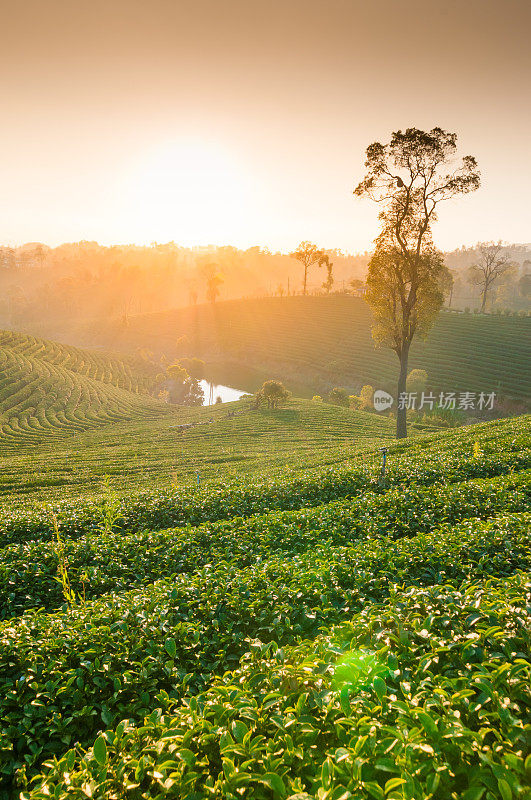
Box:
[354,128,479,439]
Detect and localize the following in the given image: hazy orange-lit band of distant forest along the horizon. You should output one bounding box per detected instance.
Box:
[0,241,531,335]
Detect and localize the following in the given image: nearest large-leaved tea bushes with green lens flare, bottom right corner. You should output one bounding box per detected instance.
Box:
[19,575,531,800]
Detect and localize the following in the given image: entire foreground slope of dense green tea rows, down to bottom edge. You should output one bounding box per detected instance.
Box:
[0,412,531,800]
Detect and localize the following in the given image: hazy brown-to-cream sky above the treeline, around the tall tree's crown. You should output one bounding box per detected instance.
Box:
[0,0,531,251]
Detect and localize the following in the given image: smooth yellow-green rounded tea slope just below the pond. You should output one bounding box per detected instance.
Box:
[0,399,402,504]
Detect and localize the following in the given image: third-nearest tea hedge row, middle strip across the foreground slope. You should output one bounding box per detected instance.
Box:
[0,470,530,619]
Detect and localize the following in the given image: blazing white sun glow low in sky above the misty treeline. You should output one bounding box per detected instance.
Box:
[120,141,250,245]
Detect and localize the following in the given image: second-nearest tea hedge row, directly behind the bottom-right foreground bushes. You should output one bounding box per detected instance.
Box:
[0,514,530,779]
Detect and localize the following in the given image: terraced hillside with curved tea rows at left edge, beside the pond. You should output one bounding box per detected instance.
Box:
[0,331,167,453]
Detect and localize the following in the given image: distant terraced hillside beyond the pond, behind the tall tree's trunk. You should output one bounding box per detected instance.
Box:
[84,295,531,403]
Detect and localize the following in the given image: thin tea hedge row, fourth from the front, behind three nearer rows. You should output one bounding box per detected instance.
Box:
[0,432,531,545]
